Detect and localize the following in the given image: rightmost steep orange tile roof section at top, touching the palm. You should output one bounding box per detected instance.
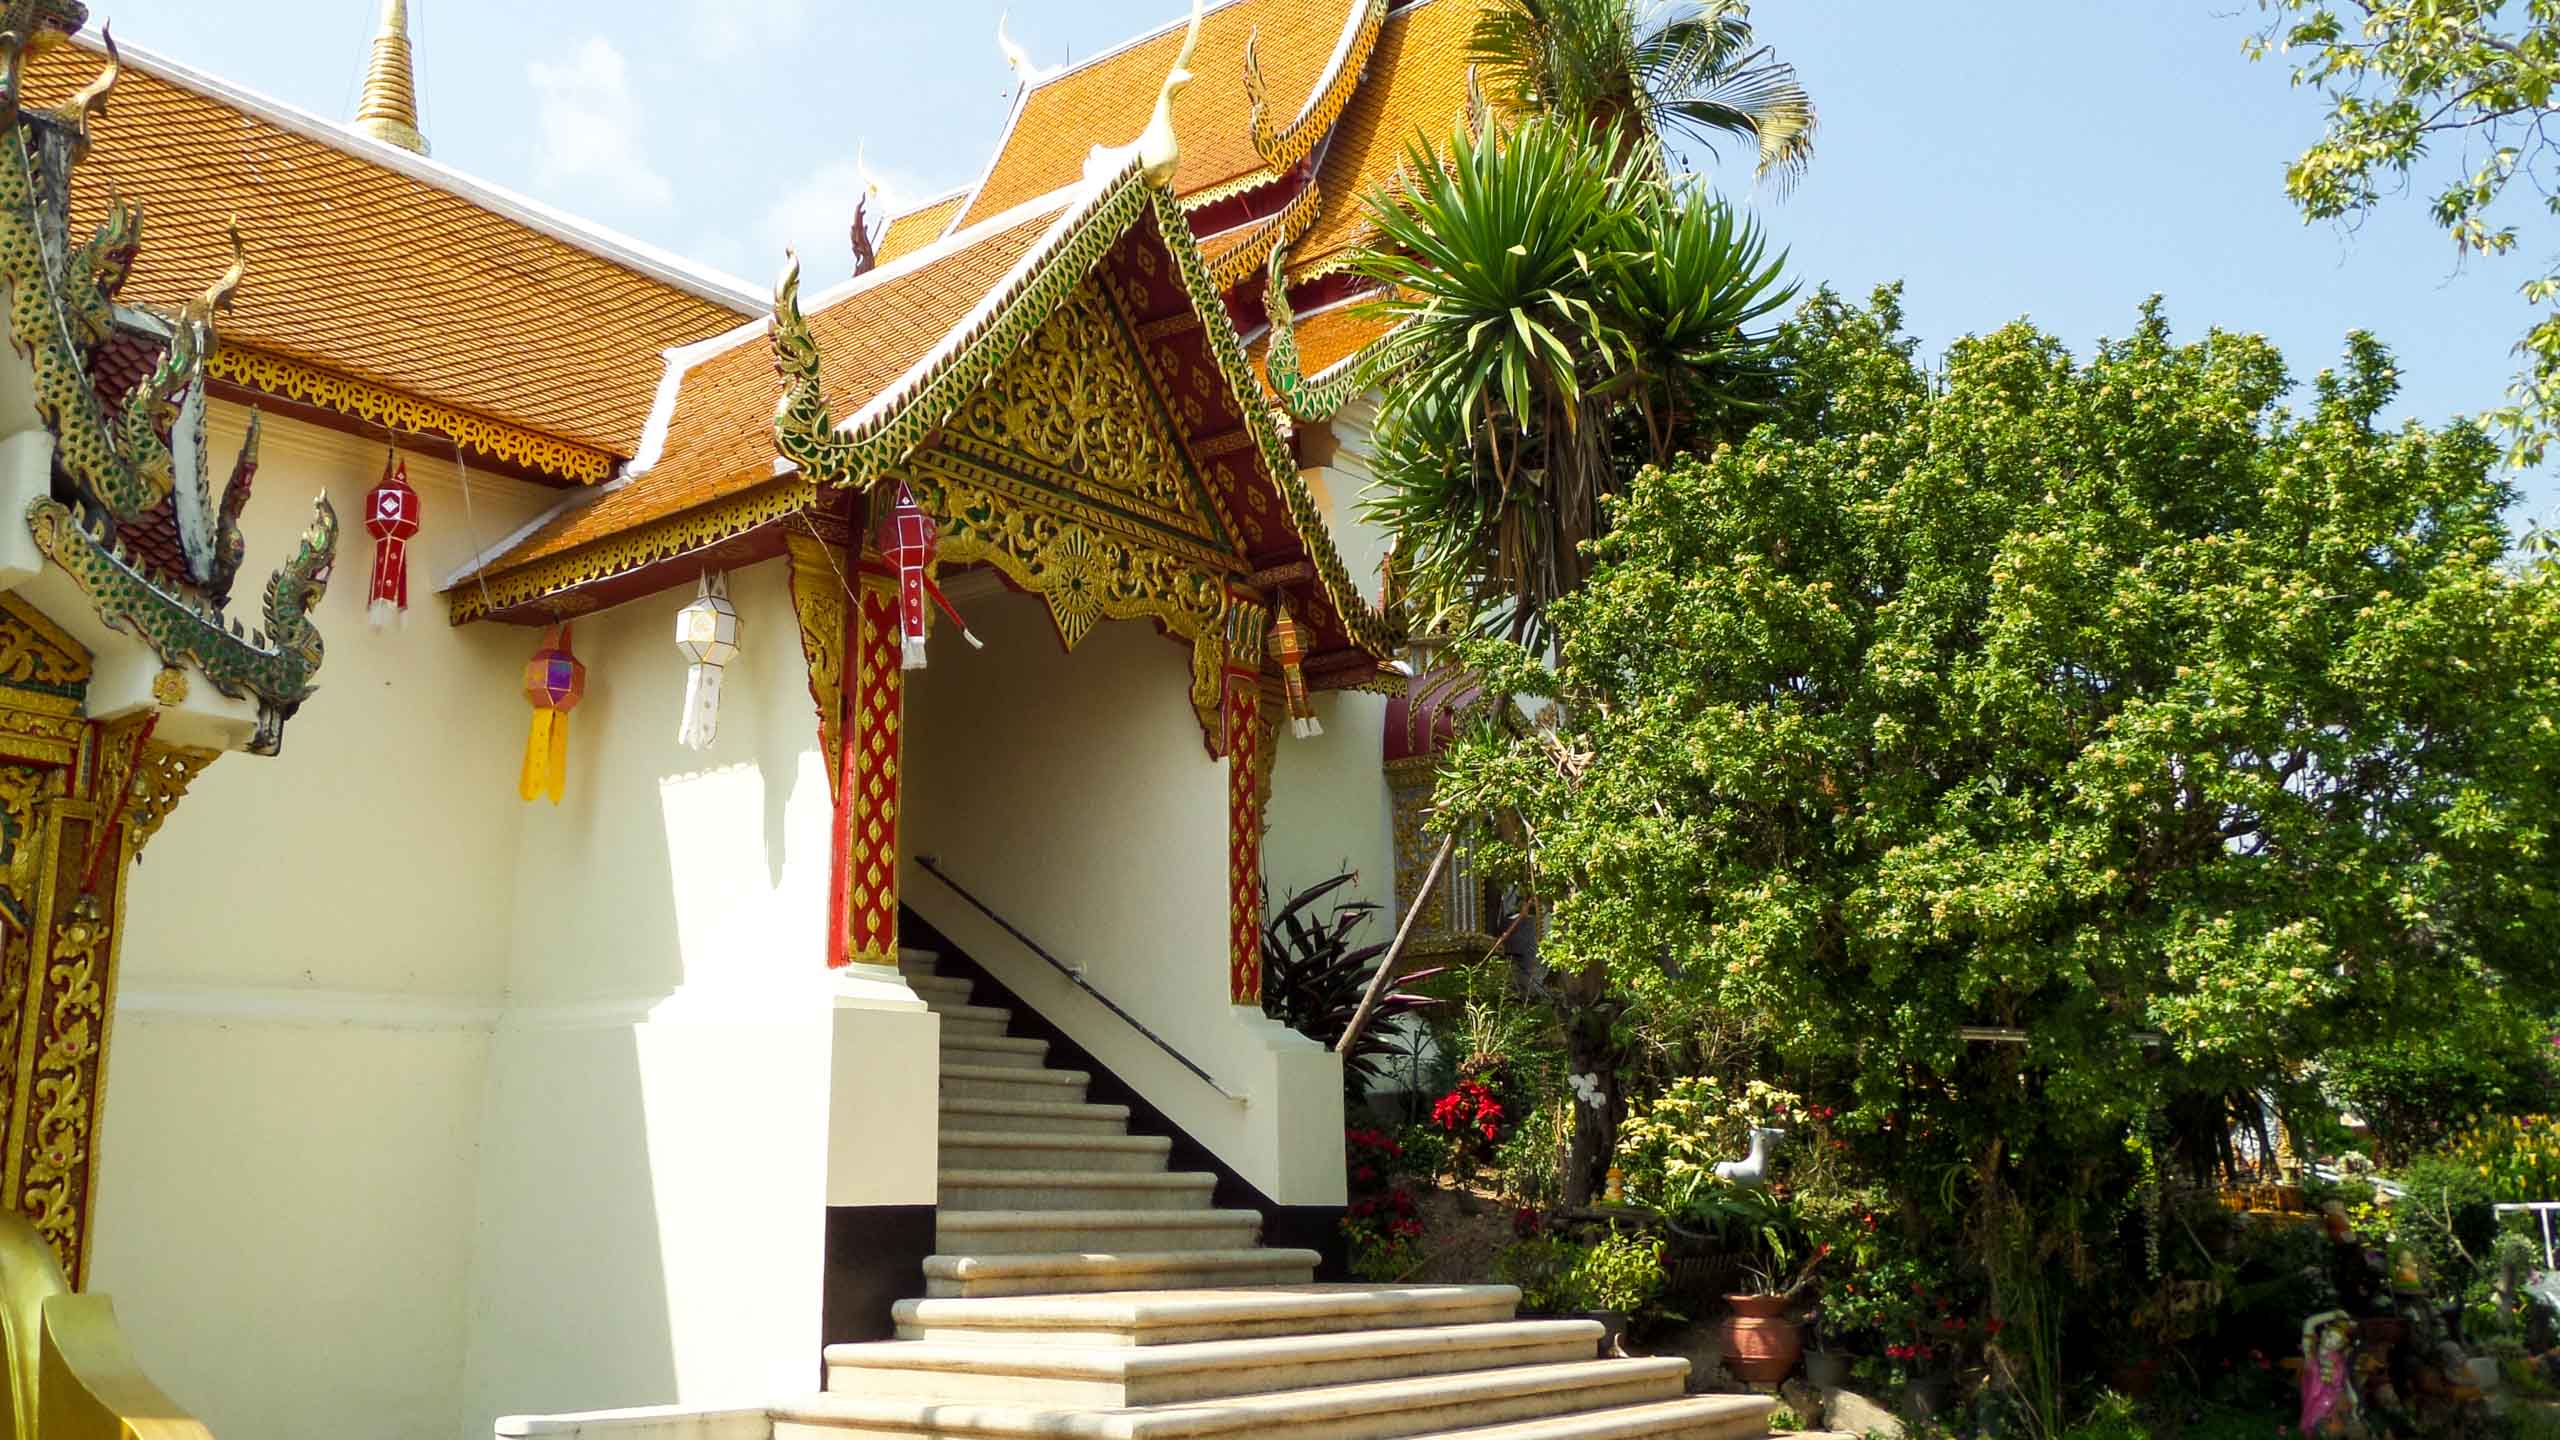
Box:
[1290,0,1487,274]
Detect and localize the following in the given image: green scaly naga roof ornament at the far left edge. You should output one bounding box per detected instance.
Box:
[0,0,338,753]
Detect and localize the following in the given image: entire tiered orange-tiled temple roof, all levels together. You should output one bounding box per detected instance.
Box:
[36,0,1485,676]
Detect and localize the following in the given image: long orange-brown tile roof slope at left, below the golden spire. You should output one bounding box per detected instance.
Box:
[28,46,753,456]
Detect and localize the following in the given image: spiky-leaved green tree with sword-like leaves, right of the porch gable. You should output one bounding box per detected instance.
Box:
[1357,120,1795,643]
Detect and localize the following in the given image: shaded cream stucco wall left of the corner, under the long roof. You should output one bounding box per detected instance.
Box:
[90,394,553,1440]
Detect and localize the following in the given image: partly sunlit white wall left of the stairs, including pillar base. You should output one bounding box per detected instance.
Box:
[463,561,940,1435]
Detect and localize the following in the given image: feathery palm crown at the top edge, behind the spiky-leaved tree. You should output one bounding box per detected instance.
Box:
[1467,0,1818,187]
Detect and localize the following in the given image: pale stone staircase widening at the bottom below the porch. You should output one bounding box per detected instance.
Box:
[771,953,1772,1440]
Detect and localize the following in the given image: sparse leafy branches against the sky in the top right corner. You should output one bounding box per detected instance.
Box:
[2250,0,2560,464]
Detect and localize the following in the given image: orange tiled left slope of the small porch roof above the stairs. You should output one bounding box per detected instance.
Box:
[486,197,1065,574]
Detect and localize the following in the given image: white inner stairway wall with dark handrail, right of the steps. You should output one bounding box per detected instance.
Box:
[904,592,1341,1204]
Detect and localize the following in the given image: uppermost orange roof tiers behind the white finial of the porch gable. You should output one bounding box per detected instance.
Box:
[960,0,1359,225]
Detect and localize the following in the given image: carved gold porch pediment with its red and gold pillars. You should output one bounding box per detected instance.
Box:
[768,272,1277,983]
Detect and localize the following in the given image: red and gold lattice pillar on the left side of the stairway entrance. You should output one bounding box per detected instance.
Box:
[827,564,906,966]
